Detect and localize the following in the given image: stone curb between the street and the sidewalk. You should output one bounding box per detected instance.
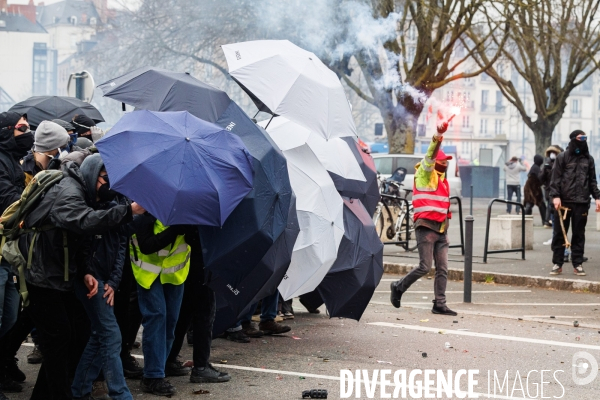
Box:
[383,262,600,293]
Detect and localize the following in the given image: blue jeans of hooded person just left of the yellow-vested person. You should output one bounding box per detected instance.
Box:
[71,280,133,400]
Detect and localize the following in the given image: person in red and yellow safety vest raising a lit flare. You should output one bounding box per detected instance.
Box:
[390,115,457,315]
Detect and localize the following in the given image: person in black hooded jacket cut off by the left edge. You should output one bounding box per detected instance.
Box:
[0,112,34,400]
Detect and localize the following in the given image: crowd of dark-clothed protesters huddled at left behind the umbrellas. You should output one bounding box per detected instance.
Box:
[0,112,294,400]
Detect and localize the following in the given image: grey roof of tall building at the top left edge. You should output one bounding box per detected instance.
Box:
[37,0,100,26]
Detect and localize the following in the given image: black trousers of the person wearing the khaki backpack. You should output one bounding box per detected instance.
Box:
[27,284,90,400]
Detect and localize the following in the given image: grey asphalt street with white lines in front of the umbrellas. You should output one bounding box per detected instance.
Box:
[9,276,600,400]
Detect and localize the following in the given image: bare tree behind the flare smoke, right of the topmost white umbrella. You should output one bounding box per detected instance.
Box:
[330,0,503,153]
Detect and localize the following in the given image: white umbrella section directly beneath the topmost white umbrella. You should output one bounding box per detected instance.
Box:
[259,117,366,182]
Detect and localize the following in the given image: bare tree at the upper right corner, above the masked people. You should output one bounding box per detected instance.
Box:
[470,0,600,154]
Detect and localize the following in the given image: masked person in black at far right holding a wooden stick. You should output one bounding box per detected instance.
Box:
[550,130,600,276]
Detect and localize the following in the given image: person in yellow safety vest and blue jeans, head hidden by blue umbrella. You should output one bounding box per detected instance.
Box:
[129,213,191,396]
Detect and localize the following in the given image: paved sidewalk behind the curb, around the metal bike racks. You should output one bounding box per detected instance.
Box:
[384,199,600,281]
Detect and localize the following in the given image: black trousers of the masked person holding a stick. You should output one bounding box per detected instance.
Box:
[552,203,589,267]
